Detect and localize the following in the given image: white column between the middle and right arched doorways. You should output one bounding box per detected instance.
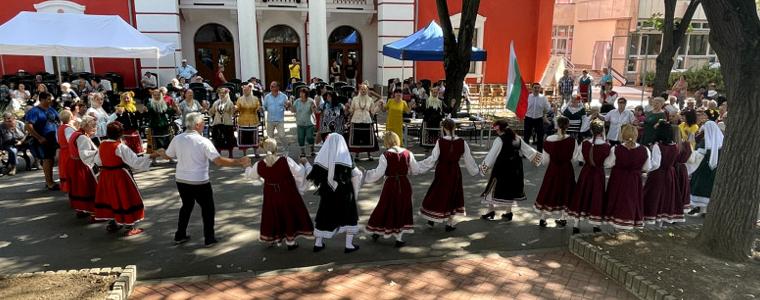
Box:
[302,1,328,81]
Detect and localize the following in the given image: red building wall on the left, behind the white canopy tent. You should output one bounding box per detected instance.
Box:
[0,0,139,87]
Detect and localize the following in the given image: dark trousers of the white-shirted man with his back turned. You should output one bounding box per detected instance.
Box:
[174,182,216,243]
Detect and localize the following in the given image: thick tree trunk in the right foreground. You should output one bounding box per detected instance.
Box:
[696,0,760,261]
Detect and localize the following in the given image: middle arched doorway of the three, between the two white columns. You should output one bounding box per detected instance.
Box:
[264,25,303,87]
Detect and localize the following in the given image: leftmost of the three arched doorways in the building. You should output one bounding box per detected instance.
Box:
[194,23,235,85]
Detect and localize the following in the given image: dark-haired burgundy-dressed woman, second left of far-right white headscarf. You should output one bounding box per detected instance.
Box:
[644,120,685,226]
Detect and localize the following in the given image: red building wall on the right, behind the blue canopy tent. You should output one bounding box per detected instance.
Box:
[415,0,554,83]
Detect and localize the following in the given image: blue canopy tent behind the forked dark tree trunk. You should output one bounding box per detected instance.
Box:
[383,21,486,88]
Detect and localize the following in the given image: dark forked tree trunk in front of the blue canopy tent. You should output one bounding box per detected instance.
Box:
[436,0,480,111]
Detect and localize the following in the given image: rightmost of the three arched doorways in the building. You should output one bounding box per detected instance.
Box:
[328,26,362,83]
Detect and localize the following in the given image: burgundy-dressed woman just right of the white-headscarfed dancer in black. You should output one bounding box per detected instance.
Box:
[364,131,420,247]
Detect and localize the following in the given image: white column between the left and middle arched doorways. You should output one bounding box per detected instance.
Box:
[237,0,261,81]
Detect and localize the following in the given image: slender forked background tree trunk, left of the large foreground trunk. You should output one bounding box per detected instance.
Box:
[652,0,702,96]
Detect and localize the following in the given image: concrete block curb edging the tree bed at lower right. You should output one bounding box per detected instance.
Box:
[568,224,702,300]
